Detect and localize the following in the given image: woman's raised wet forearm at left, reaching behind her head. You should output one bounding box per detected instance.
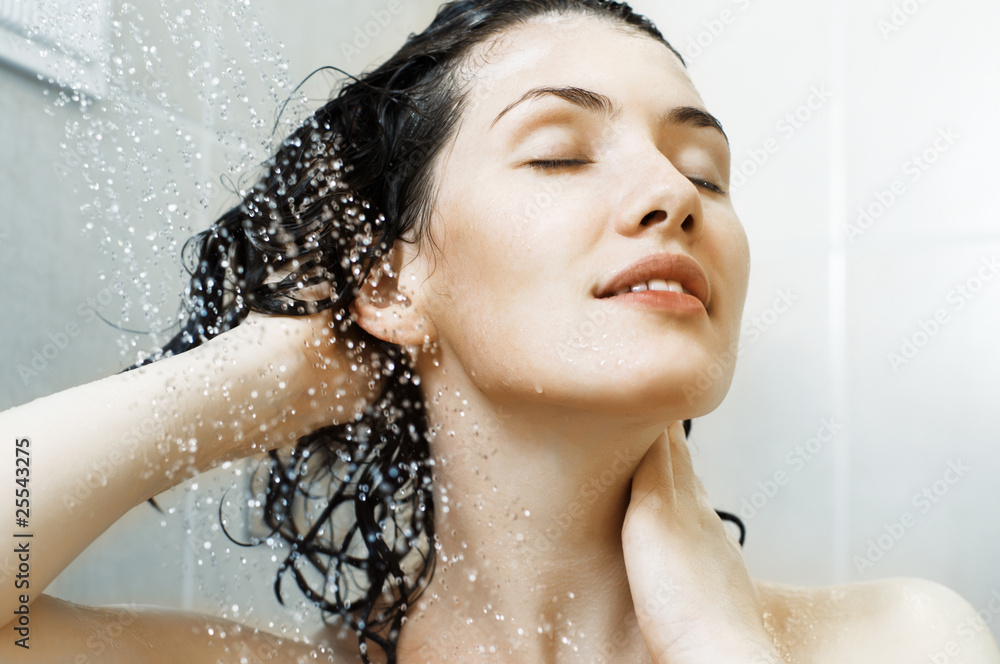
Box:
[0,316,312,616]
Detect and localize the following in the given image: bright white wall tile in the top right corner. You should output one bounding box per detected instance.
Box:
[847,0,1000,243]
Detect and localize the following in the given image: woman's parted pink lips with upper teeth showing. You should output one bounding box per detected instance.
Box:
[595,253,710,309]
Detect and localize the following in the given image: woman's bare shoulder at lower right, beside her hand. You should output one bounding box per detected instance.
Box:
[756,578,1000,664]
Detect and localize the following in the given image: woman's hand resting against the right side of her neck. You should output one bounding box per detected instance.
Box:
[622,422,783,664]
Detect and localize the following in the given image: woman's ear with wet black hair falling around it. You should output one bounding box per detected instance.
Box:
[350,242,437,346]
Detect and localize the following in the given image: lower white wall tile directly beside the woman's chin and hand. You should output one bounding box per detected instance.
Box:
[692,246,844,584]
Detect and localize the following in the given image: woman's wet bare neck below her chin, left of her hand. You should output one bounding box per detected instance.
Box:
[400,366,665,663]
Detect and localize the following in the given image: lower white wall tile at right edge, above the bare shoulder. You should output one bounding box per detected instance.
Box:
[848,243,1000,592]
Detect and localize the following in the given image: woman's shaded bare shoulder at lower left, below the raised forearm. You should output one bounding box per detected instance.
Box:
[0,595,356,664]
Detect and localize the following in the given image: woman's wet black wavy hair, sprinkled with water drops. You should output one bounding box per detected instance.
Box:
[152,0,742,663]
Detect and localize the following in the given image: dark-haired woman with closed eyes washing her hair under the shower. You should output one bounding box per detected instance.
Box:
[0,0,1000,664]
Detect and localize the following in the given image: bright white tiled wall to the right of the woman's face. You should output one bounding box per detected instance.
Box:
[636,0,1000,632]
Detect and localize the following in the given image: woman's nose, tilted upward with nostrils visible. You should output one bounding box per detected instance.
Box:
[615,148,705,243]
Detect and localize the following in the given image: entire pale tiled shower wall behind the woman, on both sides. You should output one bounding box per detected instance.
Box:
[0,0,1000,634]
